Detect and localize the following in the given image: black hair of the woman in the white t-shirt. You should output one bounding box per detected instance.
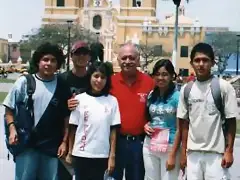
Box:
[88,61,112,96]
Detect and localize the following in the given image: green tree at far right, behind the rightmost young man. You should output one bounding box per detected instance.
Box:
[205,32,240,74]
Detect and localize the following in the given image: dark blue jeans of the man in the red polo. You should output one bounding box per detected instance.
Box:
[113,136,145,180]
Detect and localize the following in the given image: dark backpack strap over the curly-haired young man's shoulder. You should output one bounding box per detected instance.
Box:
[25,74,36,117]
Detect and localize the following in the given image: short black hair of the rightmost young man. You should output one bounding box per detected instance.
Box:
[190,42,215,62]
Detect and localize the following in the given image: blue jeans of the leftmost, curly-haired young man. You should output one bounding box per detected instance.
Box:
[15,149,59,180]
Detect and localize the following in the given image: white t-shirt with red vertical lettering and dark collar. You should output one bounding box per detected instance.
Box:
[69,93,120,158]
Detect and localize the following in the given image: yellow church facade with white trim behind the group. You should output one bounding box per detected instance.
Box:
[42,0,205,73]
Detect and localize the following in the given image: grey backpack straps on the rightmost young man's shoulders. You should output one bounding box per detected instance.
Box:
[183,76,226,139]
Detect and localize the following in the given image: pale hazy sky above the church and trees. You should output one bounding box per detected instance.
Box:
[0,0,240,41]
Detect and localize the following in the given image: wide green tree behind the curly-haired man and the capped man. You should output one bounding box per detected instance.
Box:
[20,24,97,62]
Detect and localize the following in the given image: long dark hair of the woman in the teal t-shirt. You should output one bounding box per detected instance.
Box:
[149,59,177,104]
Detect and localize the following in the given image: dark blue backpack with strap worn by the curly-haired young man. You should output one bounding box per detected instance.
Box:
[4,74,36,159]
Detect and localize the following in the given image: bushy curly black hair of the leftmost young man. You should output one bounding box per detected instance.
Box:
[30,42,65,73]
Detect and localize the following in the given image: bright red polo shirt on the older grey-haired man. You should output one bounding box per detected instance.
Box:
[111,71,154,135]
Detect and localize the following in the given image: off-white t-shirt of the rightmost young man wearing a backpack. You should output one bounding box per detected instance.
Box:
[177,79,238,153]
